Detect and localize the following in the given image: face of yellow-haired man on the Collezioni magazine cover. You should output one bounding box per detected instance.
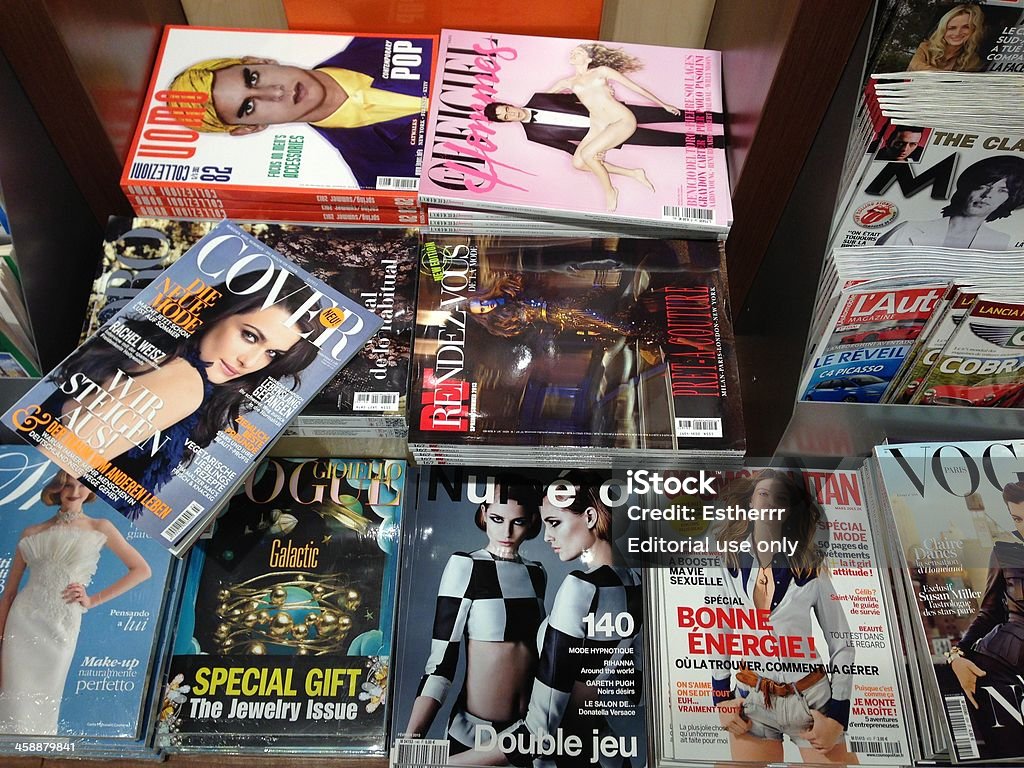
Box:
[213,62,326,125]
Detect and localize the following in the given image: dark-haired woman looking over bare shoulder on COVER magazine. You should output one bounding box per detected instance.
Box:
[43,271,316,517]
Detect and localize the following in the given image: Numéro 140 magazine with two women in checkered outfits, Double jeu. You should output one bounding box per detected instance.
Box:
[391,467,647,767]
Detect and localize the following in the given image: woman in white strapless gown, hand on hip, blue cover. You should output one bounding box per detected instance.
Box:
[0,471,152,735]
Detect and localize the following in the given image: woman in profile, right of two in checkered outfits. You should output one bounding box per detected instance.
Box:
[452,470,643,768]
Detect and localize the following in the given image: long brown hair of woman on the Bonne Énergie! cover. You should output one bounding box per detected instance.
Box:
[717,469,822,577]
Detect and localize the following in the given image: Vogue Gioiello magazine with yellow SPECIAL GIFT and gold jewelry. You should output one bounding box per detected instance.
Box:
[160,458,408,755]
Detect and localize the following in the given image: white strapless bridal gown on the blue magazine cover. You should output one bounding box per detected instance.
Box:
[0,523,106,735]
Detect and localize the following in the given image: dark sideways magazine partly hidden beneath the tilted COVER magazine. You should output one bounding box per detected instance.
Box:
[82,216,419,436]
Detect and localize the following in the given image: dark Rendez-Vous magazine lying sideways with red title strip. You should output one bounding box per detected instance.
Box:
[410,236,743,451]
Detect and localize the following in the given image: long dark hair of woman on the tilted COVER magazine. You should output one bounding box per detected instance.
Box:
[48,270,316,447]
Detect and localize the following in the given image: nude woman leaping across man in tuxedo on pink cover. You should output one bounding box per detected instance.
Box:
[548,43,680,211]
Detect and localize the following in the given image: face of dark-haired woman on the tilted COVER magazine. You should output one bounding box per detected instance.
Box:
[199,306,299,384]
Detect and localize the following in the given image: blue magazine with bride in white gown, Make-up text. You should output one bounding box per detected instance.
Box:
[0,445,177,757]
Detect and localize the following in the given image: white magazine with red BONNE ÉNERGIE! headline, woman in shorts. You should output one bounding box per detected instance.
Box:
[647,468,910,765]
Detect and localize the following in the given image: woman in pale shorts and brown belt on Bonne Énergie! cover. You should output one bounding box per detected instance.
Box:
[710,469,858,764]
